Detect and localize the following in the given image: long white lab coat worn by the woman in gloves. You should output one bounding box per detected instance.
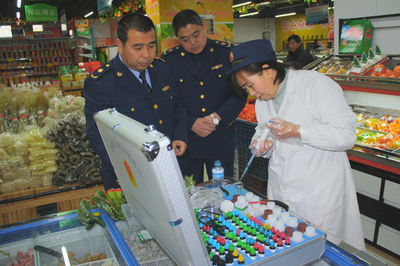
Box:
[253,70,365,250]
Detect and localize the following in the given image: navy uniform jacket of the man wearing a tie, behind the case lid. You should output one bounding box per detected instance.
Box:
[84,55,188,189]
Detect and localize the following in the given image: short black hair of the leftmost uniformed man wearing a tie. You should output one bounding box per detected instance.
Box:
[117,13,156,45]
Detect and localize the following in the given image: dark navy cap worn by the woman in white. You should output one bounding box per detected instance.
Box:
[226,39,276,75]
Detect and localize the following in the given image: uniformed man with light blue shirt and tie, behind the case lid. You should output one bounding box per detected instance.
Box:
[84,14,188,190]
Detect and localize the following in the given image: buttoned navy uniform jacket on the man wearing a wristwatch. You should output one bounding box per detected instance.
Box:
[162,39,247,159]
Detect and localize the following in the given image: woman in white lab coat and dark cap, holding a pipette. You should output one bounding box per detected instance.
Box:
[228,40,365,250]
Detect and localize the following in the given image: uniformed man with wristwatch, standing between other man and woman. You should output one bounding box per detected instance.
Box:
[162,9,247,183]
